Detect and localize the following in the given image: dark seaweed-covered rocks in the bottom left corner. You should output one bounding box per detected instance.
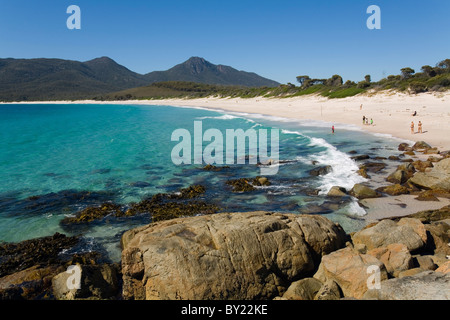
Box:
[0,233,120,300]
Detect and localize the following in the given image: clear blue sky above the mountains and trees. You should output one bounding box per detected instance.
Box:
[0,0,450,83]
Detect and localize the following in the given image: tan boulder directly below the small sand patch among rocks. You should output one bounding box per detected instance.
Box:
[352,218,426,251]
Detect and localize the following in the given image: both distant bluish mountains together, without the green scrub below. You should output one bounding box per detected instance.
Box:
[0,57,278,101]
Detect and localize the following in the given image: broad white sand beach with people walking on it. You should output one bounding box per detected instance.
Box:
[134,92,450,150]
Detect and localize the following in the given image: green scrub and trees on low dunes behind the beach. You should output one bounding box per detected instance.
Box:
[100,59,450,100]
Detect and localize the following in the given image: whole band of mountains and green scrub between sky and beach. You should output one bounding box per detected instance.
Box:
[0,57,450,101]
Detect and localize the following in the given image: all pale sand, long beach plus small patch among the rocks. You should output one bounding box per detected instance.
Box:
[3,92,450,221]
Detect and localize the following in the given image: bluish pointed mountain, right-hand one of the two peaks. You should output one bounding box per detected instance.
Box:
[145,57,279,87]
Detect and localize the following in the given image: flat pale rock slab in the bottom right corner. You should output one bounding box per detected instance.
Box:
[363,271,450,300]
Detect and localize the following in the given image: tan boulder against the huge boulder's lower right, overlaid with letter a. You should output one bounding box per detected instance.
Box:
[314,247,388,299]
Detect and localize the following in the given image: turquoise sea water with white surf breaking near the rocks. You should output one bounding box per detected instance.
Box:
[0,104,398,260]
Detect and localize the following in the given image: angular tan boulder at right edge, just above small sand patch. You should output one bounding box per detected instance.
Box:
[409,158,450,191]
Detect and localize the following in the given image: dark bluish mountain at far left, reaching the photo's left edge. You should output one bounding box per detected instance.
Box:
[0,57,148,101]
